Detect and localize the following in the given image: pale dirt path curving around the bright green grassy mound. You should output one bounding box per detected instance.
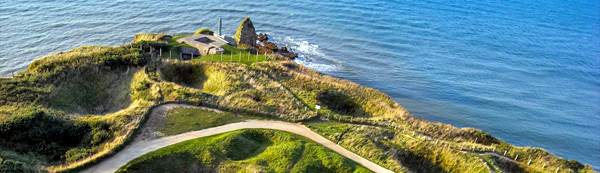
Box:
[82,104,392,172]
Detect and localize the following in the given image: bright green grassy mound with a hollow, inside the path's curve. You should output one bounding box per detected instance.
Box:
[117,130,369,172]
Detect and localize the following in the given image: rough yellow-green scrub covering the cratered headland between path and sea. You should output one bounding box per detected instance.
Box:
[0,34,592,172]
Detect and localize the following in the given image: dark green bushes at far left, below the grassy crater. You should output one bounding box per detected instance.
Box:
[0,108,112,162]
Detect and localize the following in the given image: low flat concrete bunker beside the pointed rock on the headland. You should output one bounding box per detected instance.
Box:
[177,34,227,56]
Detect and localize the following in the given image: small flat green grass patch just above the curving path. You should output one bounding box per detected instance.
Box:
[160,107,266,136]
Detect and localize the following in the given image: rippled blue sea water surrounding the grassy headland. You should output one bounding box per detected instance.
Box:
[0,0,600,169]
